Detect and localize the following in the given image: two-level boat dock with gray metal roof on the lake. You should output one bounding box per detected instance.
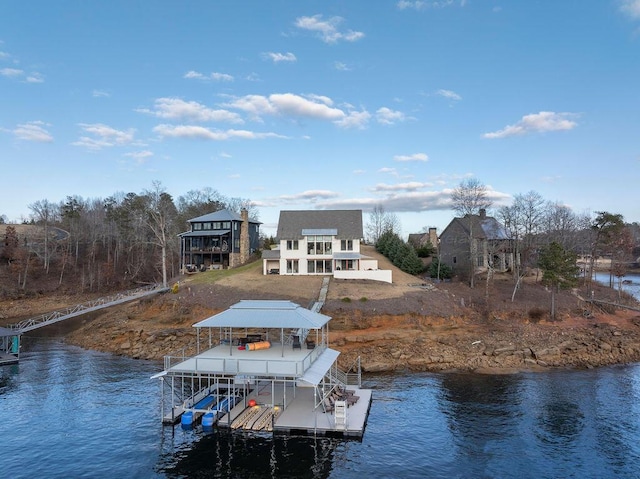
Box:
[153,301,372,438]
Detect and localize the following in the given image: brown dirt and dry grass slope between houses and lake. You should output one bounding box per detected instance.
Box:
[5,251,640,374]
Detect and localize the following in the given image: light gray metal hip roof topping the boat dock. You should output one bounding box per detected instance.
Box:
[193,300,331,329]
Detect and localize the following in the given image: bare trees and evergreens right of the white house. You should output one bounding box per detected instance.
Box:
[367,178,640,316]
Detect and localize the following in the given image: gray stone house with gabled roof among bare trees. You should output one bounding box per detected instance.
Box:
[439,209,515,282]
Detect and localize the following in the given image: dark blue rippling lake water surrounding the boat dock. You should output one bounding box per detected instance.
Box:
[0,338,640,479]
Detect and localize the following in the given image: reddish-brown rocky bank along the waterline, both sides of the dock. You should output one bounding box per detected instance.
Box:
[61,302,640,373]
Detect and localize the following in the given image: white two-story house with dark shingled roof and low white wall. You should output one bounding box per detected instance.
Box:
[262,210,391,283]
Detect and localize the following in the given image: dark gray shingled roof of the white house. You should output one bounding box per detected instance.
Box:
[277,210,364,240]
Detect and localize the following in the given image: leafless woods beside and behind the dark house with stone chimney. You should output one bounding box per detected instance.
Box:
[0,182,257,294]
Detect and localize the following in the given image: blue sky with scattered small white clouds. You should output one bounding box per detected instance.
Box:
[0,0,640,235]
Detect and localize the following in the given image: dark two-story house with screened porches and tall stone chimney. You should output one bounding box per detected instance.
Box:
[178,209,261,271]
